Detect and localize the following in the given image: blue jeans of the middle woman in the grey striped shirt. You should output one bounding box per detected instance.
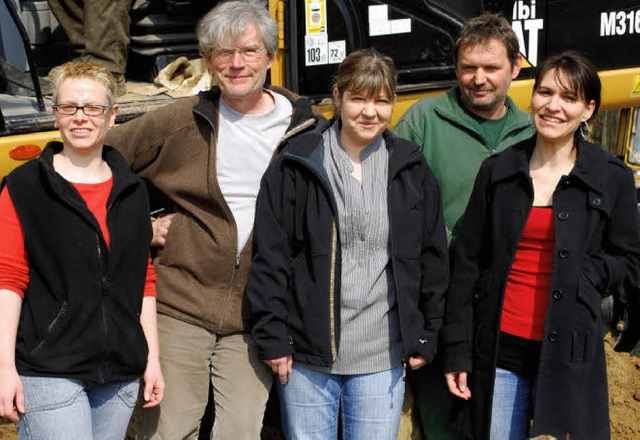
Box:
[276,363,404,440]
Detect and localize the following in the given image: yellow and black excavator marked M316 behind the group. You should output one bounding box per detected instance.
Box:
[0,0,640,438]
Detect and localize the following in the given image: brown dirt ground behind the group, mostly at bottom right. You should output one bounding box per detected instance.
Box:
[0,337,640,440]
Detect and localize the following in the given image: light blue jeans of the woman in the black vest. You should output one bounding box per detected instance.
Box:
[17,376,140,440]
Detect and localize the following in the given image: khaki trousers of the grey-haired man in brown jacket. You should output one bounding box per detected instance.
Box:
[138,314,273,440]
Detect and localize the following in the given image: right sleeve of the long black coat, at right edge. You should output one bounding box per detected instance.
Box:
[583,164,640,294]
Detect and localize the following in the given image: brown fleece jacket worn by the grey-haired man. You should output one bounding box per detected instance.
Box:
[106,87,319,335]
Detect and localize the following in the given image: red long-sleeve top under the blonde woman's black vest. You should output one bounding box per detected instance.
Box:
[0,179,156,298]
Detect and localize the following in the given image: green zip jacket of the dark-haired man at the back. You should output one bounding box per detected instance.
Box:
[395,86,535,239]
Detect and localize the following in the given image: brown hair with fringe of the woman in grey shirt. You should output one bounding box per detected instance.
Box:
[332,48,398,115]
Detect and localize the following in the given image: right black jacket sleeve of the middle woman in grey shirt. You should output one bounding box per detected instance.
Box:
[417,161,449,362]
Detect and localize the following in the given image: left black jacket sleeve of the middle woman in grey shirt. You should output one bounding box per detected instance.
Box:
[245,160,293,360]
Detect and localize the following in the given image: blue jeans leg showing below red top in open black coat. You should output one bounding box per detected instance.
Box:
[490,368,534,440]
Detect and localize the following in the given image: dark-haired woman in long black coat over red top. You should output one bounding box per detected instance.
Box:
[442,52,640,440]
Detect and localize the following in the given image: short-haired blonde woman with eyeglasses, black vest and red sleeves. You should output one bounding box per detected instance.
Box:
[0,62,164,440]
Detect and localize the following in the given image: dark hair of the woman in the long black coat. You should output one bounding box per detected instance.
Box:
[533,51,602,120]
